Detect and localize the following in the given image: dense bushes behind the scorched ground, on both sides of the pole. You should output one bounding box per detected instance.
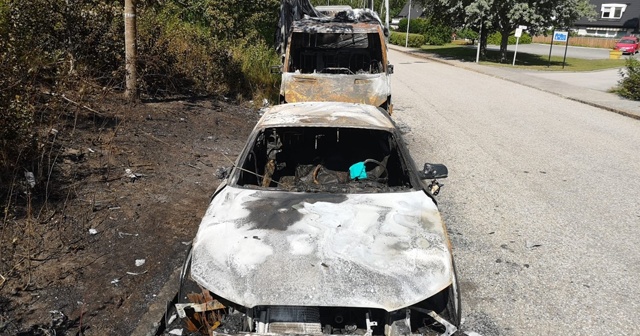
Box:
[0,0,280,190]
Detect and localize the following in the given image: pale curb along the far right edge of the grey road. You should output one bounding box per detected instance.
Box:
[389,44,640,120]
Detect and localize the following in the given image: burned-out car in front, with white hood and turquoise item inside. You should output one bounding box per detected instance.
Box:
[175,102,460,336]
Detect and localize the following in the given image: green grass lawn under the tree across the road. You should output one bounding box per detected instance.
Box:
[421,44,625,71]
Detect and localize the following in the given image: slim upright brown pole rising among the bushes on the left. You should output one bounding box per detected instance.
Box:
[124,0,138,101]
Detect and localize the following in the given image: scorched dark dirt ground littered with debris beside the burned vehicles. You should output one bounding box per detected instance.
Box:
[0,93,258,335]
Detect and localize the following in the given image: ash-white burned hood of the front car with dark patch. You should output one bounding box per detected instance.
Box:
[191,187,453,311]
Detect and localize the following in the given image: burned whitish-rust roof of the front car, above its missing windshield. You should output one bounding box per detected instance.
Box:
[256,102,395,131]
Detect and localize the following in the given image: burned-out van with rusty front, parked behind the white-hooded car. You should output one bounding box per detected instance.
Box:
[273,5,393,113]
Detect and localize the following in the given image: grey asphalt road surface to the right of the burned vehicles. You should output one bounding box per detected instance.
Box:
[390,51,640,336]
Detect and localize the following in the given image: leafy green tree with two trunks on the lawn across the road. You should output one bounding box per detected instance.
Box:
[421,0,596,61]
